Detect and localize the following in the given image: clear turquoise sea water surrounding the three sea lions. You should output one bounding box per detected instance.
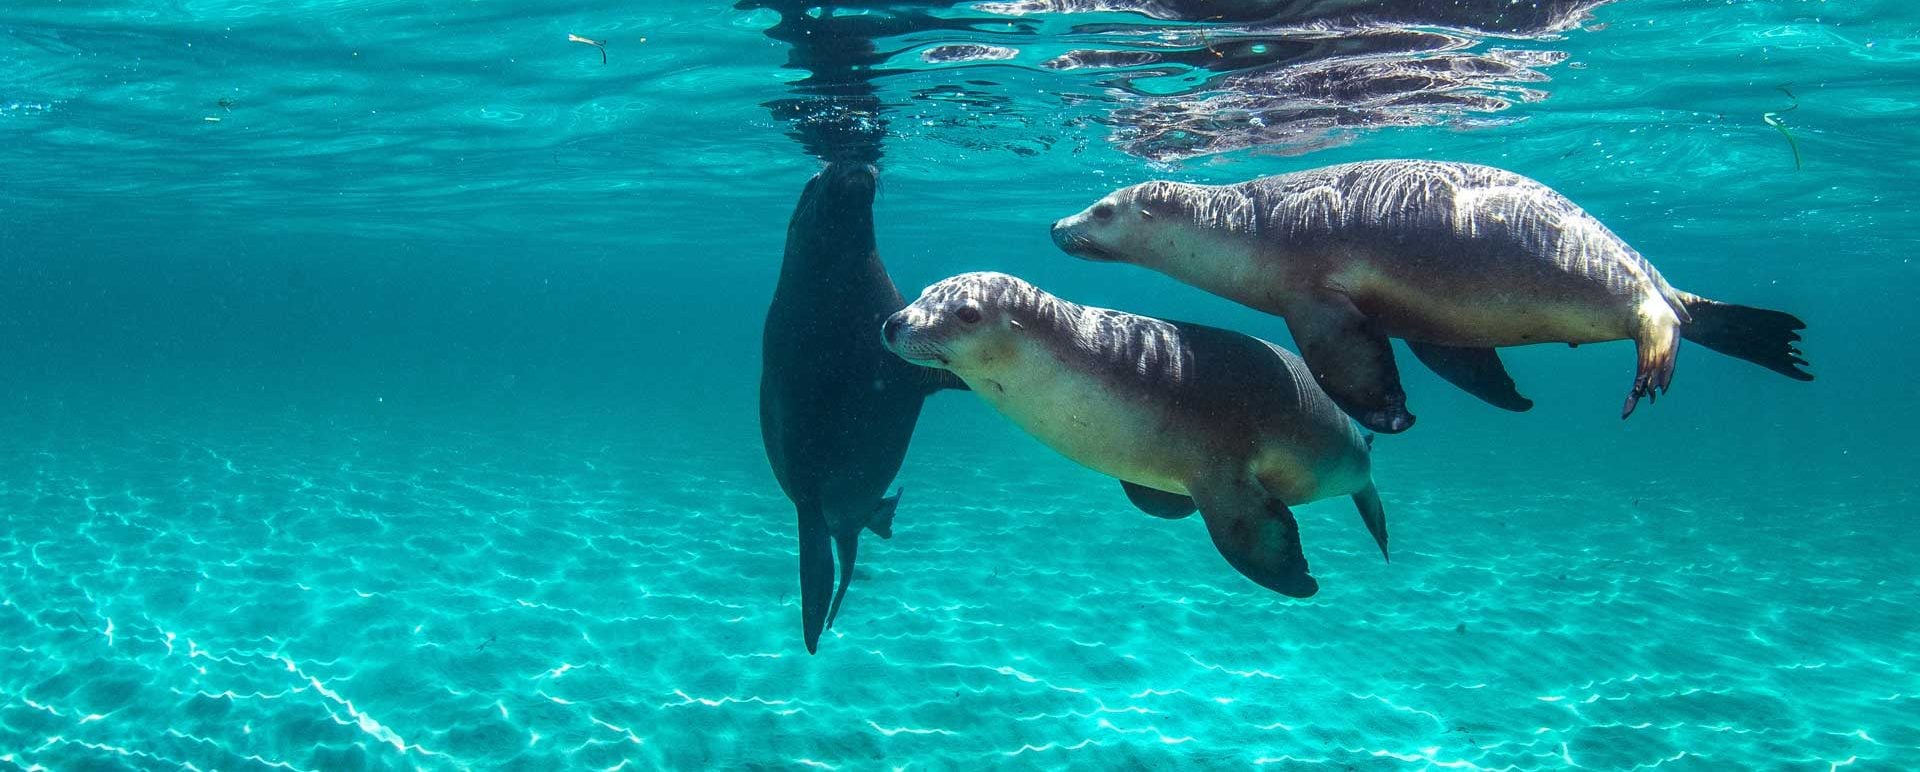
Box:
[0,0,1920,770]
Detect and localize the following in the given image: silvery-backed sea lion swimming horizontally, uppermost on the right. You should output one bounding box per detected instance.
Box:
[1052,161,1812,432]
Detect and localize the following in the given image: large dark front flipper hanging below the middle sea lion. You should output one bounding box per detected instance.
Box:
[1192,480,1319,597]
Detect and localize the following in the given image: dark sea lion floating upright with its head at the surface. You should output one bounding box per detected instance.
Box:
[760,163,964,653]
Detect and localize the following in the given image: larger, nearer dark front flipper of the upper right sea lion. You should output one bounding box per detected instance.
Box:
[1282,292,1413,434]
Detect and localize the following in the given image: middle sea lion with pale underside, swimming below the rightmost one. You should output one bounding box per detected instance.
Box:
[881,273,1386,597]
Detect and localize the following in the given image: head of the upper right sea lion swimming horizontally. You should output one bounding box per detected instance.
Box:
[1054,181,1254,269]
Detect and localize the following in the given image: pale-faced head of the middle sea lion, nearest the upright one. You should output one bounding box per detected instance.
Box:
[879,273,1052,376]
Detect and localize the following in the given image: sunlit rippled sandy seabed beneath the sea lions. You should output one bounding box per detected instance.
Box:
[0,405,1920,770]
